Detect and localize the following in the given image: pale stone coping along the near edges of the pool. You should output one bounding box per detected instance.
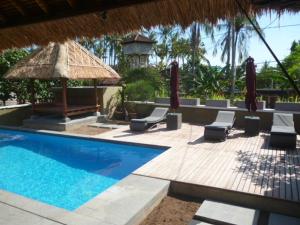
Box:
[0,175,170,225]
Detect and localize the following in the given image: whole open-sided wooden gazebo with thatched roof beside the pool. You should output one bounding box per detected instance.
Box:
[5,40,120,119]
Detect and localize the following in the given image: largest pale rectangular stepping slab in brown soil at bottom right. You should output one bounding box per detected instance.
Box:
[195,200,259,225]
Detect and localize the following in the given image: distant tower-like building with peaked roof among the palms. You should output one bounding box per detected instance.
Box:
[122,34,155,68]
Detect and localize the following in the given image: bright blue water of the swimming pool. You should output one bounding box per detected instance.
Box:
[0,129,163,210]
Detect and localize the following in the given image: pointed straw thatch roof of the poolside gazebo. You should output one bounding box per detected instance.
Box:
[5,41,120,83]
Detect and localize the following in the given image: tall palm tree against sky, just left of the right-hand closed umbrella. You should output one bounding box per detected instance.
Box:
[214,15,262,97]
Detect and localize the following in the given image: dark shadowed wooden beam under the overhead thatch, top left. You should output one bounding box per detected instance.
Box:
[0,0,159,29]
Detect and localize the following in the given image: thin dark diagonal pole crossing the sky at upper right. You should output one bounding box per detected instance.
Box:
[235,0,300,96]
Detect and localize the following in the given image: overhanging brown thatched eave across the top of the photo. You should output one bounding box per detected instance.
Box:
[0,0,300,50]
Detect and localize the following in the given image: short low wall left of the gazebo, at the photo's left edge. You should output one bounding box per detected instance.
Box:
[0,104,32,126]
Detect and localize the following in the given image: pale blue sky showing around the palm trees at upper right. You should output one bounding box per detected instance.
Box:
[202,13,300,68]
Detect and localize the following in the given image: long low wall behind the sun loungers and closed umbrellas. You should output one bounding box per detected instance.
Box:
[126,102,300,133]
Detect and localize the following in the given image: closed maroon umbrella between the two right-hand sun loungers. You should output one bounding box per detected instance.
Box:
[245,57,257,112]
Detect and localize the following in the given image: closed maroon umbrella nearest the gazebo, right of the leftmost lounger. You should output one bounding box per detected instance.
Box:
[170,61,179,111]
